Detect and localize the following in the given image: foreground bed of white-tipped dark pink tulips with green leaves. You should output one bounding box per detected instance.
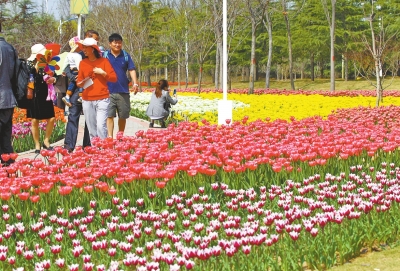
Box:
[0,161,400,271]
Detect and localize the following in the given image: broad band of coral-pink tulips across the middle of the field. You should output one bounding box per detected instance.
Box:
[0,107,400,204]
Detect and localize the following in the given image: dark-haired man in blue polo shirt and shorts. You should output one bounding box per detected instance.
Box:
[103,33,139,138]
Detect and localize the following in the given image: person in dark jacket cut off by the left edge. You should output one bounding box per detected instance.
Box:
[0,30,17,165]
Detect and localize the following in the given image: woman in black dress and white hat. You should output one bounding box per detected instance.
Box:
[27,44,56,154]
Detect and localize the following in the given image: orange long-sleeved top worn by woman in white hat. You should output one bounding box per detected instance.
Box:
[76,57,117,101]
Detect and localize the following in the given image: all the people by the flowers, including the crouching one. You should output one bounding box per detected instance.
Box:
[0,27,178,166]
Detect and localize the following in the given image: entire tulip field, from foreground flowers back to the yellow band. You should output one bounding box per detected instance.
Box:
[0,91,400,271]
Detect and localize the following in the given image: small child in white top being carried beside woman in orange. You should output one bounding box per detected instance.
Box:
[62,37,82,106]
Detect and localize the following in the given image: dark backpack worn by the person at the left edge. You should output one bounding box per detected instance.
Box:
[11,50,32,109]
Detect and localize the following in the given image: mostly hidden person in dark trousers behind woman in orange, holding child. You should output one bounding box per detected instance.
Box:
[64,30,99,152]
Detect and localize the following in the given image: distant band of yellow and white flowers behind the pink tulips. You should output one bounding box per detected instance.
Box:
[131,91,400,124]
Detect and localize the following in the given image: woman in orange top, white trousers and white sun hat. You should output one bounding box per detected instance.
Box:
[76,38,117,140]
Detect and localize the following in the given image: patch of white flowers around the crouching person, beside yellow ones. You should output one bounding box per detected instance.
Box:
[131,92,250,114]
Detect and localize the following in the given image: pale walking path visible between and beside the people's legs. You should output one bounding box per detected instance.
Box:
[17,115,149,161]
